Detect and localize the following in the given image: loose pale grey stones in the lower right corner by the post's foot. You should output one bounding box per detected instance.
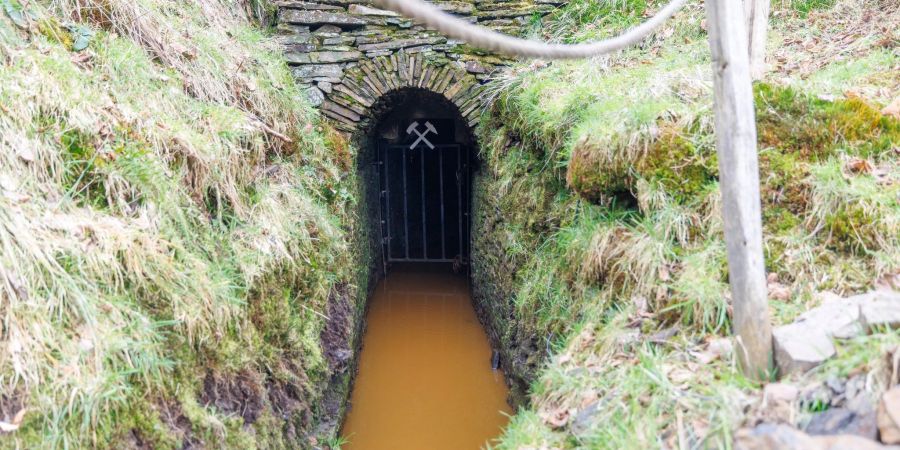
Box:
[733,306,900,450]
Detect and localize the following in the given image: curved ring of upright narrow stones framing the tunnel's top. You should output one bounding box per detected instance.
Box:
[321,50,484,133]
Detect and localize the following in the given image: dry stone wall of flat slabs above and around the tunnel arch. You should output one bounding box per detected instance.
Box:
[276,0,565,132]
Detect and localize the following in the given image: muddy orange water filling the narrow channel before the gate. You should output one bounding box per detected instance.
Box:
[342,267,510,450]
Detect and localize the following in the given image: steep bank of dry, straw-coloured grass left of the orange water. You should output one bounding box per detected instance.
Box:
[0,0,367,449]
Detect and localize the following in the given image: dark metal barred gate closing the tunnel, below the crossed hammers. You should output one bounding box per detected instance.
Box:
[378,143,469,263]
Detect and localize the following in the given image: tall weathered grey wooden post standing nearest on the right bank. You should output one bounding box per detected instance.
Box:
[706,0,772,380]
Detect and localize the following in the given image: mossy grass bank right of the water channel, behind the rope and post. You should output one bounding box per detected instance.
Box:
[473,0,900,449]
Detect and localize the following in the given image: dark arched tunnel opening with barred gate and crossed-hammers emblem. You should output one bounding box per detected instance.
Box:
[364,88,476,270]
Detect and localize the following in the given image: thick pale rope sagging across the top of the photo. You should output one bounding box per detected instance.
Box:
[373,0,687,59]
